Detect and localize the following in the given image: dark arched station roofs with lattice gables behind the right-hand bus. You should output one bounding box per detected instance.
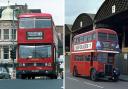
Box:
[66,0,128,48]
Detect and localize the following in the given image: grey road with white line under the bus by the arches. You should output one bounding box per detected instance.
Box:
[65,71,128,89]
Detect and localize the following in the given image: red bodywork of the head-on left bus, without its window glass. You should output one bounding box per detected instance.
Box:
[16,13,57,78]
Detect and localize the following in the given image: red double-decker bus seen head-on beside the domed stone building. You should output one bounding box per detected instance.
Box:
[16,13,58,79]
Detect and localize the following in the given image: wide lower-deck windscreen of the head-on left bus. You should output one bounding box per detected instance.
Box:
[19,45,52,58]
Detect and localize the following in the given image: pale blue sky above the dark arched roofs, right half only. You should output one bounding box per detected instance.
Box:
[65,0,105,24]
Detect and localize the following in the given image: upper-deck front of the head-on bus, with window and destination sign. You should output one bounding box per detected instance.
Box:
[18,14,53,43]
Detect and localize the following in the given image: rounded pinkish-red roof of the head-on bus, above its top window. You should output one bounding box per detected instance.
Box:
[18,13,52,18]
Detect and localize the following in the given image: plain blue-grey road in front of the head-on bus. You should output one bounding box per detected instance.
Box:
[0,79,63,89]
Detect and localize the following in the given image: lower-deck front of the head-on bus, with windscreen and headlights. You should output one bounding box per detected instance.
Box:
[17,44,54,73]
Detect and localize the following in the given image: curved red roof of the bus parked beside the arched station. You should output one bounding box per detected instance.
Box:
[74,28,116,38]
